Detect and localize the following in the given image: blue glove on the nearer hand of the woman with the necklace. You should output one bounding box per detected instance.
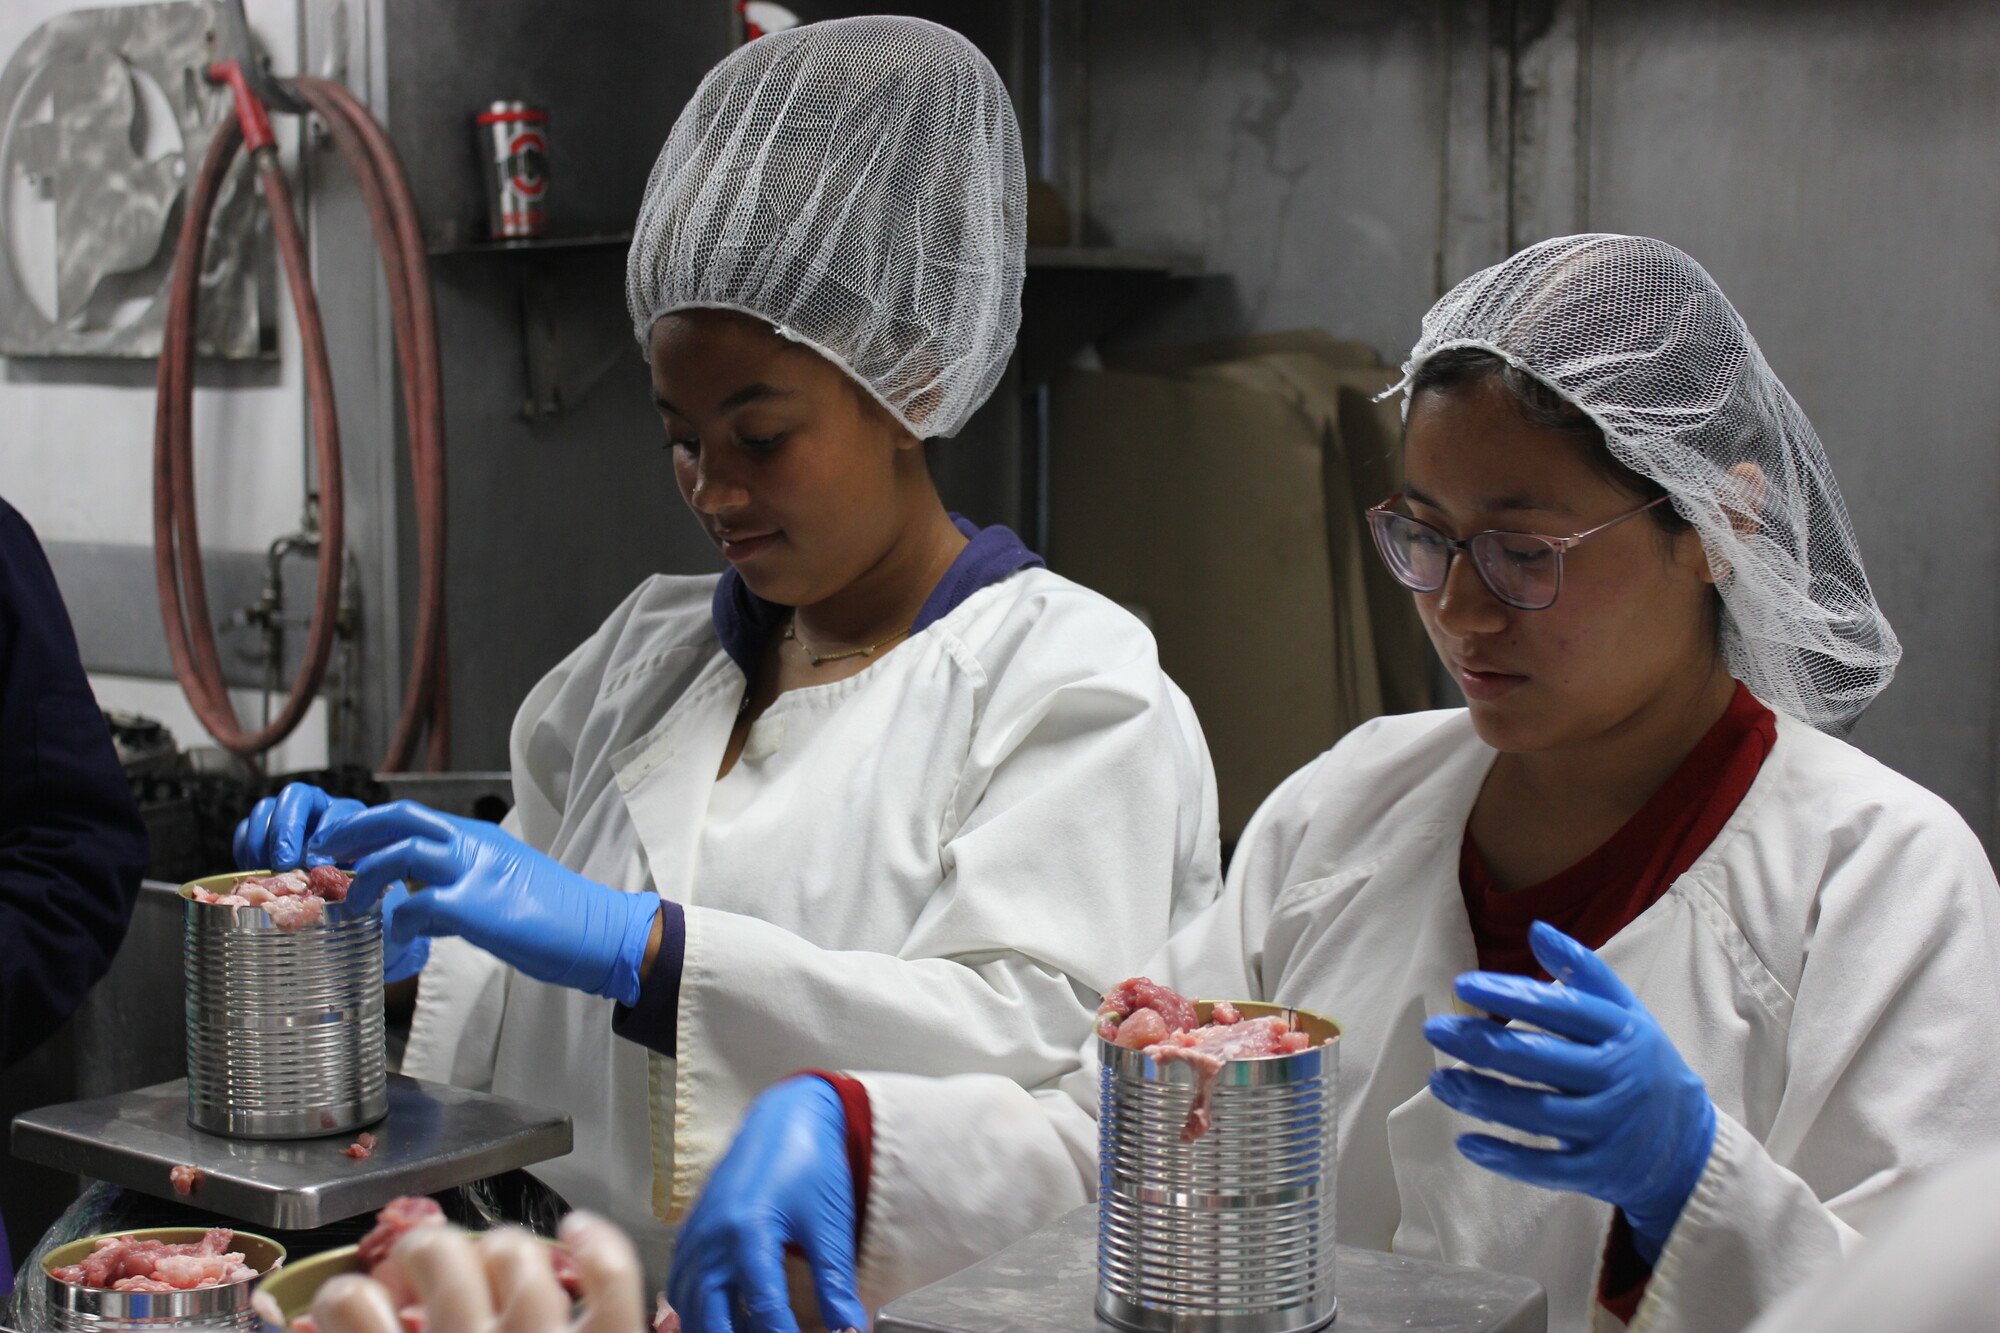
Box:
[308,801,660,1005]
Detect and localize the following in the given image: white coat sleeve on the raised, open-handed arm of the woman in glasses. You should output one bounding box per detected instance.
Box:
[1632,801,2000,1333]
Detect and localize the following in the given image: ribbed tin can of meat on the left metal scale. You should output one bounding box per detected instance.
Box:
[180,873,388,1139]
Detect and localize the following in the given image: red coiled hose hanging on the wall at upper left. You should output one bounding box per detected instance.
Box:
[152,62,450,773]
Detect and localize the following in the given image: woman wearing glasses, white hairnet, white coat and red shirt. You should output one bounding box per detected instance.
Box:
[676,236,2000,1331]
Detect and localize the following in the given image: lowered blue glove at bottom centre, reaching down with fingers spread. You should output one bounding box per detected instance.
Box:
[666,1075,868,1333]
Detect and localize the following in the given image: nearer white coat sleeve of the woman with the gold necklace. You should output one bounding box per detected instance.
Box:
[674,638,1216,1197]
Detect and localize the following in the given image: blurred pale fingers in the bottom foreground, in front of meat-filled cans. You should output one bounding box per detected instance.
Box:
[312,1213,646,1333]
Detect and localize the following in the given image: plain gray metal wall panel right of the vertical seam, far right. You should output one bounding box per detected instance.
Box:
[1588,0,2000,845]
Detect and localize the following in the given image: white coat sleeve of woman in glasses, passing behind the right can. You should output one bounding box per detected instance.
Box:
[836,761,1320,1309]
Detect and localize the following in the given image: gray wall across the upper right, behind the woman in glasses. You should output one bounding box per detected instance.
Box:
[1066,0,2000,841]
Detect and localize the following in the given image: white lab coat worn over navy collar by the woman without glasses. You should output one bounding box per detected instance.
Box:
[404,568,1220,1281]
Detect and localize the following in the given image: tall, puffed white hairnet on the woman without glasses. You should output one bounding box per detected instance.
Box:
[626,18,1028,436]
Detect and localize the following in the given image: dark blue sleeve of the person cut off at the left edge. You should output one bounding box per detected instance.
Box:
[0,500,146,1067]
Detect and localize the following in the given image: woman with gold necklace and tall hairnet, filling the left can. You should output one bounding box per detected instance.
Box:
[238,18,1216,1283]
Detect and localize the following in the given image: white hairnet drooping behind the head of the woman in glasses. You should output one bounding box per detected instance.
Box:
[1402,234,1902,733]
